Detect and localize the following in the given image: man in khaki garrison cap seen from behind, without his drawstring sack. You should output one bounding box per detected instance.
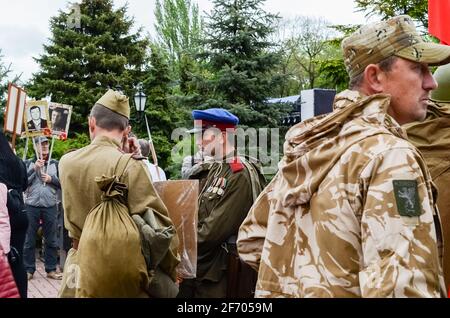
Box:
[59,90,176,297]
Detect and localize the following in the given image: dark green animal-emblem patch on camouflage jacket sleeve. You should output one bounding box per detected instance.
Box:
[392,180,421,217]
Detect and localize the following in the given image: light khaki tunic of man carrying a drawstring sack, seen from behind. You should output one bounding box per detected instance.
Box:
[59,136,172,297]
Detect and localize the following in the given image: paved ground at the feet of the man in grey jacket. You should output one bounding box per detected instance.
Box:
[28,257,61,298]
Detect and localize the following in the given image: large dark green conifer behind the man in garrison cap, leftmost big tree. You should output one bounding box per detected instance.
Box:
[27,0,148,132]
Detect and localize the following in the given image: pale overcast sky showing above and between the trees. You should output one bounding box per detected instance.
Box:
[0,0,366,81]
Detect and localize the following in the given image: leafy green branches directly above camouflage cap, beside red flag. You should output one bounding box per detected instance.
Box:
[355,0,428,30]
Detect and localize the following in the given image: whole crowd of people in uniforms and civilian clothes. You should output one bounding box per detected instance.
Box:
[0,15,450,298]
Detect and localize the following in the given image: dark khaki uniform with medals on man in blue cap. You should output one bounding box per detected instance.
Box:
[179,162,264,298]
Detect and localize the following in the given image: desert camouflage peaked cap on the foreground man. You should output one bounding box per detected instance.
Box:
[342,15,450,78]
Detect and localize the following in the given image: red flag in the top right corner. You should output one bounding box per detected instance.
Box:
[428,0,450,45]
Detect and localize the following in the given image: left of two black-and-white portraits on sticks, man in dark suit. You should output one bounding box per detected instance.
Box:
[24,101,52,137]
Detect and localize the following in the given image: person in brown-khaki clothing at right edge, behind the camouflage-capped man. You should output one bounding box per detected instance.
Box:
[405,64,450,289]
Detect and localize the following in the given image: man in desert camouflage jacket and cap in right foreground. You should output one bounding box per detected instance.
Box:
[238,16,450,297]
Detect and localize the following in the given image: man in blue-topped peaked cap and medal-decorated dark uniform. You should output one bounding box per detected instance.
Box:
[178,109,264,298]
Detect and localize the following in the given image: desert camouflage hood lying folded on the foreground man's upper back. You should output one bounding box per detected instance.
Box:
[278,90,406,207]
